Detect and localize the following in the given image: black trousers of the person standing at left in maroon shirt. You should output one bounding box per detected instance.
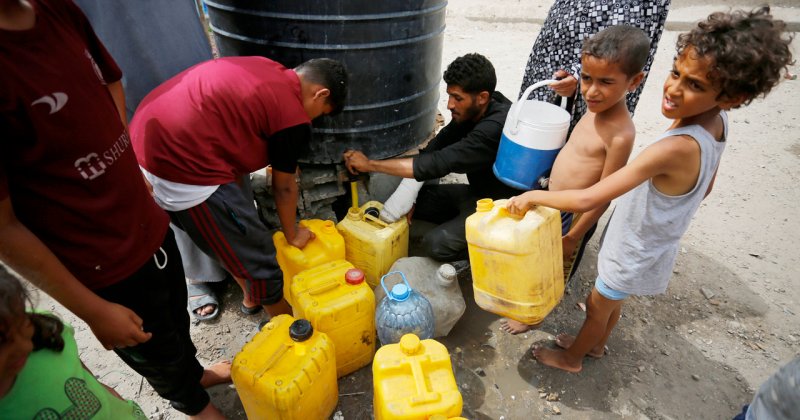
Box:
[95,229,209,416]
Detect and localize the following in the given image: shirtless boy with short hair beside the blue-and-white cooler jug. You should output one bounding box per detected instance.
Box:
[501,25,650,334]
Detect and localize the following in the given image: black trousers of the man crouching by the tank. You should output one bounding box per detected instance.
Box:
[414,184,478,262]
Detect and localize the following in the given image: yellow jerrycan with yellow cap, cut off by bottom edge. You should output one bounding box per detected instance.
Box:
[372,334,463,420]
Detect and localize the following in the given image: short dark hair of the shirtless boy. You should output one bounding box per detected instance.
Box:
[581,25,650,78]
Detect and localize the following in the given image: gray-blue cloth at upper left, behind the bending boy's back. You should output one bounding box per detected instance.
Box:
[75,0,211,119]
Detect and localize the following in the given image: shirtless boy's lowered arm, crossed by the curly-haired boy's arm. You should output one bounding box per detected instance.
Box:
[562,136,634,257]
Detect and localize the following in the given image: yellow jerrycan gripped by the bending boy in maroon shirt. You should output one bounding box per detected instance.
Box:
[272,219,345,305]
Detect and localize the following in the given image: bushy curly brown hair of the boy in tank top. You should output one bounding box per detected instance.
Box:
[677,6,794,105]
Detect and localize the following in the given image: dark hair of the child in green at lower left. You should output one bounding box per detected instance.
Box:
[0,266,64,352]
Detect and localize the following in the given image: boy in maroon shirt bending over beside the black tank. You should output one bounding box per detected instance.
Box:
[130,57,347,316]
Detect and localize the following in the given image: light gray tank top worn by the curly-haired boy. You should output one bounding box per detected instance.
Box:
[597,112,728,295]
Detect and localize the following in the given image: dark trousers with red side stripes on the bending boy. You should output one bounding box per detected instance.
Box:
[169,180,283,305]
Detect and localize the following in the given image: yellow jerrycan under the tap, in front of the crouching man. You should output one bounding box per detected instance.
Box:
[336,201,408,289]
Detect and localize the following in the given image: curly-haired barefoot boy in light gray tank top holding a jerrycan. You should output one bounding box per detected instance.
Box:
[506,7,792,372]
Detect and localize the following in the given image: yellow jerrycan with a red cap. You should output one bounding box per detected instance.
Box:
[292,260,375,377]
